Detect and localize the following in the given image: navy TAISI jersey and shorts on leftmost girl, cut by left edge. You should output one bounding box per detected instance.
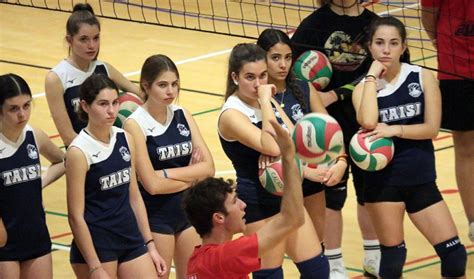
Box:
[0,125,51,262]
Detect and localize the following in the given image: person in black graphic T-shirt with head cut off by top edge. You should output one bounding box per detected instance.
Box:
[291,0,380,279]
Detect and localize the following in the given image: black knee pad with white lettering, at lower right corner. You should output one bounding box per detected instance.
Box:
[434,236,467,278]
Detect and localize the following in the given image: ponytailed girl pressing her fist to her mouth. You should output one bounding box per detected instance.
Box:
[218,44,329,278]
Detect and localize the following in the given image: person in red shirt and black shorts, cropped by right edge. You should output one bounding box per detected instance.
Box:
[421,0,474,242]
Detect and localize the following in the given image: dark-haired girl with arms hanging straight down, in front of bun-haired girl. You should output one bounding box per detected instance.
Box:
[66,75,166,278]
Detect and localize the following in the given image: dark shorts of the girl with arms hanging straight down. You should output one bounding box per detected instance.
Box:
[69,240,148,264]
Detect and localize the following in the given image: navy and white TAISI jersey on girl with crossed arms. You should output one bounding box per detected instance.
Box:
[130,105,193,210]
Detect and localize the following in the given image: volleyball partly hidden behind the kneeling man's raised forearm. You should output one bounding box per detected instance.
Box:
[258,158,303,196]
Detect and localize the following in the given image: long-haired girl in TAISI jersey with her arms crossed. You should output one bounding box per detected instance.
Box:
[125,55,214,278]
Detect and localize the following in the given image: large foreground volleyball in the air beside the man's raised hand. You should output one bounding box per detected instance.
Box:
[292,112,344,164]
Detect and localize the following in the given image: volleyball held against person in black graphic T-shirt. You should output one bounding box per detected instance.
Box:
[293,50,332,90]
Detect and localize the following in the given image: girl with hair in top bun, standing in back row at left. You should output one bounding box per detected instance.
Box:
[45,3,142,146]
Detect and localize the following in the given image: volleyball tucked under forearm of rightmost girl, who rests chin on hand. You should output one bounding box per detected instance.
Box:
[349,133,395,171]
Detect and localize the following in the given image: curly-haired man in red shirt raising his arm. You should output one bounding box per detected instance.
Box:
[183,122,304,279]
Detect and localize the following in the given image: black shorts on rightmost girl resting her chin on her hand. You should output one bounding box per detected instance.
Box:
[364,182,443,213]
